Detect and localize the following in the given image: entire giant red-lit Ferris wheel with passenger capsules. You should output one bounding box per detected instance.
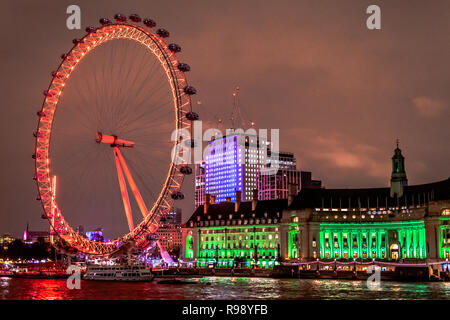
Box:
[33,14,198,255]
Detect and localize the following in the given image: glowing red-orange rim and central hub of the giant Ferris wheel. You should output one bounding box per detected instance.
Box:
[33,19,195,256]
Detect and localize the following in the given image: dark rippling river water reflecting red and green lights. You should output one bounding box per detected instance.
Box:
[0,277,450,300]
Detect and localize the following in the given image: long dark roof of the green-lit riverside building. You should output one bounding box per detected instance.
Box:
[184,178,450,226]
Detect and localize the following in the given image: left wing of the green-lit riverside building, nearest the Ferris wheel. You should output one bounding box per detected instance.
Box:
[183,192,287,268]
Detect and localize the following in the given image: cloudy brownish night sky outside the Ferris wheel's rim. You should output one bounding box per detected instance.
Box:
[0,0,450,236]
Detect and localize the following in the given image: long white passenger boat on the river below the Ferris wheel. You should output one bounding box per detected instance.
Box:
[83,264,153,281]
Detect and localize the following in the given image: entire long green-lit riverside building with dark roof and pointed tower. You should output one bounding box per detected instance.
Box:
[182,146,450,268]
